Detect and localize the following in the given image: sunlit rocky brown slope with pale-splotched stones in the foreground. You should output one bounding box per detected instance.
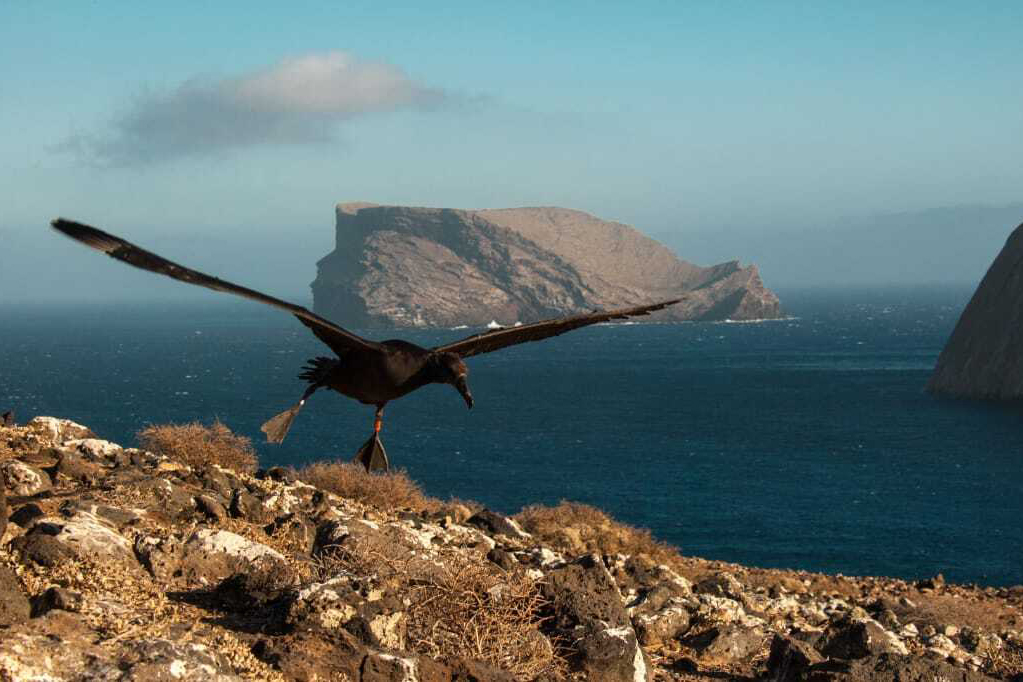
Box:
[0,417,1023,682]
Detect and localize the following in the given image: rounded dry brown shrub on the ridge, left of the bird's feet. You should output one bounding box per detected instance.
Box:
[136,419,259,473]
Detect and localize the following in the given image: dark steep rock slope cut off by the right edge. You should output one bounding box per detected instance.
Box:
[927,225,1023,400]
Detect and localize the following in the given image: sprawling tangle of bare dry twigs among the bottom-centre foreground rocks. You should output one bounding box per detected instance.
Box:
[318,536,567,680]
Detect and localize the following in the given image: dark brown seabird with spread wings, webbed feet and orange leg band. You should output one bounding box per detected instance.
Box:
[51,218,681,471]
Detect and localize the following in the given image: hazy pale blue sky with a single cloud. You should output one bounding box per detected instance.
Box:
[0,0,1023,303]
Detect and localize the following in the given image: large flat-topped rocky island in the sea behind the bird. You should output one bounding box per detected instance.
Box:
[312,203,780,326]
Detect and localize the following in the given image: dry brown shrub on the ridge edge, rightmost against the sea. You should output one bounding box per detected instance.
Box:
[515,500,678,563]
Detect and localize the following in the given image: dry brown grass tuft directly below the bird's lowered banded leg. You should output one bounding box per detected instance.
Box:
[296,461,441,513]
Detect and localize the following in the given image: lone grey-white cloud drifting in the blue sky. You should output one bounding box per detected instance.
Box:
[74,51,448,166]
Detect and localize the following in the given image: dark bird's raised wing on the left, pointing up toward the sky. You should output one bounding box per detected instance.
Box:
[50,218,380,354]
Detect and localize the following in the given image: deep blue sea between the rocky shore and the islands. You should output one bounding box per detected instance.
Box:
[0,287,1023,585]
